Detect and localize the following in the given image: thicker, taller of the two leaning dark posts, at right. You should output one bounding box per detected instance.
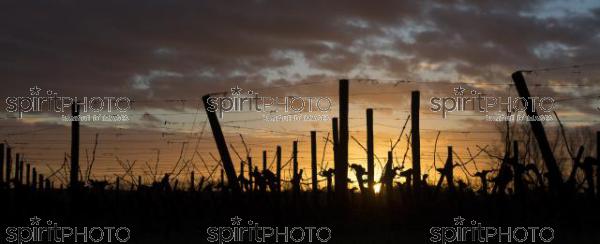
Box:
[512,71,562,193]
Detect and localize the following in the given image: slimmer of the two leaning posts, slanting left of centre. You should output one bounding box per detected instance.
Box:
[202,95,241,192]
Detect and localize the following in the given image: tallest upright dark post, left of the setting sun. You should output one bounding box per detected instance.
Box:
[335,79,349,195]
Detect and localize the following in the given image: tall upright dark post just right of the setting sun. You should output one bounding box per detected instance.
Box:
[410,91,421,189]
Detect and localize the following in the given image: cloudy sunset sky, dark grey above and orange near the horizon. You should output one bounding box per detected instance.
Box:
[0,0,600,189]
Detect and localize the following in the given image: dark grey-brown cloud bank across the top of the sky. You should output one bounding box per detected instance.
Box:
[0,0,600,112]
